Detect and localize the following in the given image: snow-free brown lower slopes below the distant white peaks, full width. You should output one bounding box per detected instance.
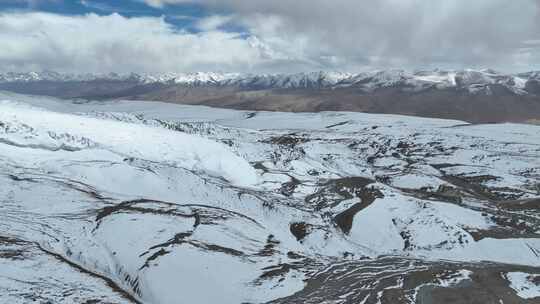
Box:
[0,80,540,124]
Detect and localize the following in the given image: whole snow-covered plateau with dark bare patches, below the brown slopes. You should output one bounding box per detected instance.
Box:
[0,91,540,304]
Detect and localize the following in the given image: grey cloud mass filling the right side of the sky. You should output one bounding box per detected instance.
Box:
[140,0,540,69]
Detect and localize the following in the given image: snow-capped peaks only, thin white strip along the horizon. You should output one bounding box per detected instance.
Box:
[0,69,540,94]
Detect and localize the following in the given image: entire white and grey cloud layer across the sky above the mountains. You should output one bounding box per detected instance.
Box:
[0,0,540,72]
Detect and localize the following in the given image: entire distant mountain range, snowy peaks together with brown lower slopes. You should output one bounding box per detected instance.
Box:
[0,69,540,123]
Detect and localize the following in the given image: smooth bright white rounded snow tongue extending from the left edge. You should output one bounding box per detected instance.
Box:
[0,101,257,186]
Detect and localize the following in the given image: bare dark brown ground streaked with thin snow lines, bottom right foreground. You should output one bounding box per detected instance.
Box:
[271,257,540,304]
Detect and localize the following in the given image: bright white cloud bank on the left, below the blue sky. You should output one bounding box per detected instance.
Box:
[0,13,310,72]
